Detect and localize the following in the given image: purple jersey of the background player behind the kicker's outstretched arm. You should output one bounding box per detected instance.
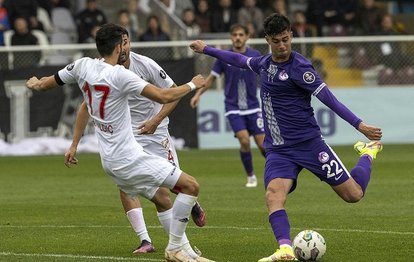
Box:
[211,48,261,115]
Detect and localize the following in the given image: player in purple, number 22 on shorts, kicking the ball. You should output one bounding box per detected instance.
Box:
[190,14,382,262]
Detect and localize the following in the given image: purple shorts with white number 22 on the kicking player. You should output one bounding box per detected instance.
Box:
[264,137,350,192]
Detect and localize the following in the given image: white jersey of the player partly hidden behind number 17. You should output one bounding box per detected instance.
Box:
[128,52,174,136]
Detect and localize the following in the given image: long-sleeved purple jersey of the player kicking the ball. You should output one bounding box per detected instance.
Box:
[203,46,362,152]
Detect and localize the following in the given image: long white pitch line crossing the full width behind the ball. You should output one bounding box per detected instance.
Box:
[0,225,414,236]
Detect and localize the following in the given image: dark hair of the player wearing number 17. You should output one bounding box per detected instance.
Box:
[95,24,128,57]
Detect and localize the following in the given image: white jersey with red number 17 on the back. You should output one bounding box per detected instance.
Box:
[58,57,148,161]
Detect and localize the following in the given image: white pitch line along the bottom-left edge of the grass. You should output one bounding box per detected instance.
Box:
[0,252,164,261]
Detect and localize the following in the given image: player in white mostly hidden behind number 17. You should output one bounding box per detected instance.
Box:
[66,31,209,261]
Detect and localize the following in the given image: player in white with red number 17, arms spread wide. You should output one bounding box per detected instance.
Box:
[26,24,215,262]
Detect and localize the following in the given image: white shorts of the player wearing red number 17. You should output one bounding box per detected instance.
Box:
[102,151,182,200]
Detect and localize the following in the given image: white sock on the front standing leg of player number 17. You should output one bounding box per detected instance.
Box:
[167,193,197,250]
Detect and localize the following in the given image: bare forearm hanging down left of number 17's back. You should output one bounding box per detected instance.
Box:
[65,101,89,167]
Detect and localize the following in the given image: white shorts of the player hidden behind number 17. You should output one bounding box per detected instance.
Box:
[135,131,180,167]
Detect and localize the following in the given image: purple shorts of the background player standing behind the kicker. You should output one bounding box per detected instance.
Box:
[227,112,264,136]
